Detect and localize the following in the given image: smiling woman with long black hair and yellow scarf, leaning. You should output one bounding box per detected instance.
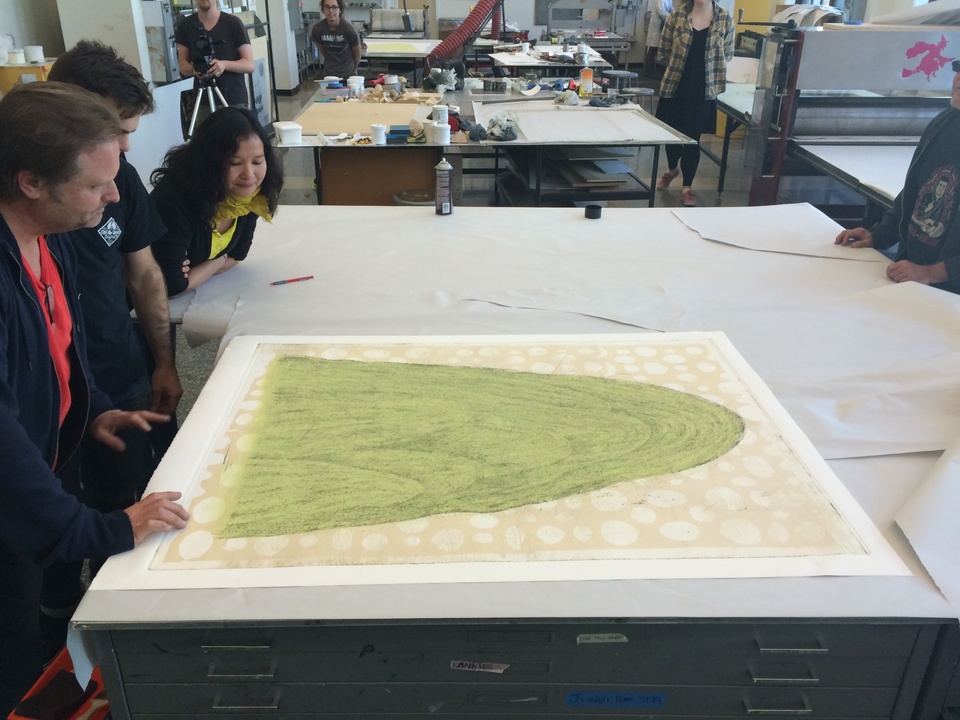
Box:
[151,107,283,297]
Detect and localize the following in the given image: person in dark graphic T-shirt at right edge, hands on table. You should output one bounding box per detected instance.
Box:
[836,60,960,293]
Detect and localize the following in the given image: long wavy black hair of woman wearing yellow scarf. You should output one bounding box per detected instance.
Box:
[150,107,283,221]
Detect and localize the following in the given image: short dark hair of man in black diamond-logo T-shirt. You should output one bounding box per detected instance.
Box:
[47,40,154,120]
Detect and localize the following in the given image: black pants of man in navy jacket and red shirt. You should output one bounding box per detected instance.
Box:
[0,542,43,718]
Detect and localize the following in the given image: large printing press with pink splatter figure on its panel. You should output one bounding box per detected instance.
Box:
[747,23,960,224]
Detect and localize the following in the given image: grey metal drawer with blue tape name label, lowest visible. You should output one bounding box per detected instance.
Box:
[126,683,897,718]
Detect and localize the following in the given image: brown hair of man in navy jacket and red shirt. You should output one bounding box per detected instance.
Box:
[0,82,123,202]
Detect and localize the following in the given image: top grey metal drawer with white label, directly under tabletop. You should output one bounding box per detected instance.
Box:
[111,621,919,659]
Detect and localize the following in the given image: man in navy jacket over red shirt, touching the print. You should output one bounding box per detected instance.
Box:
[0,83,187,717]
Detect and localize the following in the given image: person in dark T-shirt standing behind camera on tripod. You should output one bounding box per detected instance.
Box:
[174,0,253,117]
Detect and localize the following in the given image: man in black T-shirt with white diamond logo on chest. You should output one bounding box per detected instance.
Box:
[40,40,183,658]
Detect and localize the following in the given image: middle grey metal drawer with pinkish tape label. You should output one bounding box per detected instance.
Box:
[119,647,907,688]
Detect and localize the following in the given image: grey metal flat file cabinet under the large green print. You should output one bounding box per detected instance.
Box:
[88,619,960,720]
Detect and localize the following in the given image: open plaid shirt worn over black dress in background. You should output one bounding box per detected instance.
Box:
[657,0,734,100]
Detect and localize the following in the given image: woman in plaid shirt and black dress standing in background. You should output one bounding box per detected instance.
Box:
[657,0,734,207]
